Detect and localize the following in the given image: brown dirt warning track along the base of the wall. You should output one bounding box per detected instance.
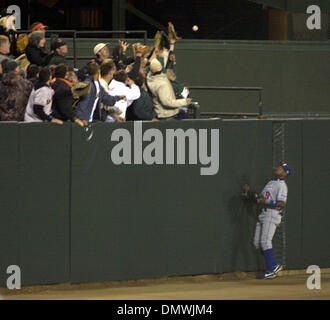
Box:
[0,269,330,300]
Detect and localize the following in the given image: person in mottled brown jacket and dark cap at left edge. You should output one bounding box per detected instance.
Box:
[0,60,33,121]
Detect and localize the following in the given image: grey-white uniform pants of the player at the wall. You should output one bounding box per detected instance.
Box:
[253,209,282,251]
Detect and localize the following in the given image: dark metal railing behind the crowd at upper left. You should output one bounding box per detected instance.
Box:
[18,30,148,68]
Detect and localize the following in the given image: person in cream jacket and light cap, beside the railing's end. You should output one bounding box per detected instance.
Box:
[147,59,192,120]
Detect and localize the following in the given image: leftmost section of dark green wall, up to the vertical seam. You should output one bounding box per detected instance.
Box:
[0,123,71,285]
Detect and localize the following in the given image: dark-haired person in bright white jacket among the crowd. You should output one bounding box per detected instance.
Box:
[109,70,141,118]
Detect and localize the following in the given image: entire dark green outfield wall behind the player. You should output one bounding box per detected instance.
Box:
[0,120,330,286]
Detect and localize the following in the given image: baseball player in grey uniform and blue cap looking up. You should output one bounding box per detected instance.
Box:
[243,163,291,279]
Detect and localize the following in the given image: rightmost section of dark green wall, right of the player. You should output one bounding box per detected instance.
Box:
[301,121,330,267]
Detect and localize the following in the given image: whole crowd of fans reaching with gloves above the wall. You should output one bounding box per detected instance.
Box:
[0,11,192,127]
